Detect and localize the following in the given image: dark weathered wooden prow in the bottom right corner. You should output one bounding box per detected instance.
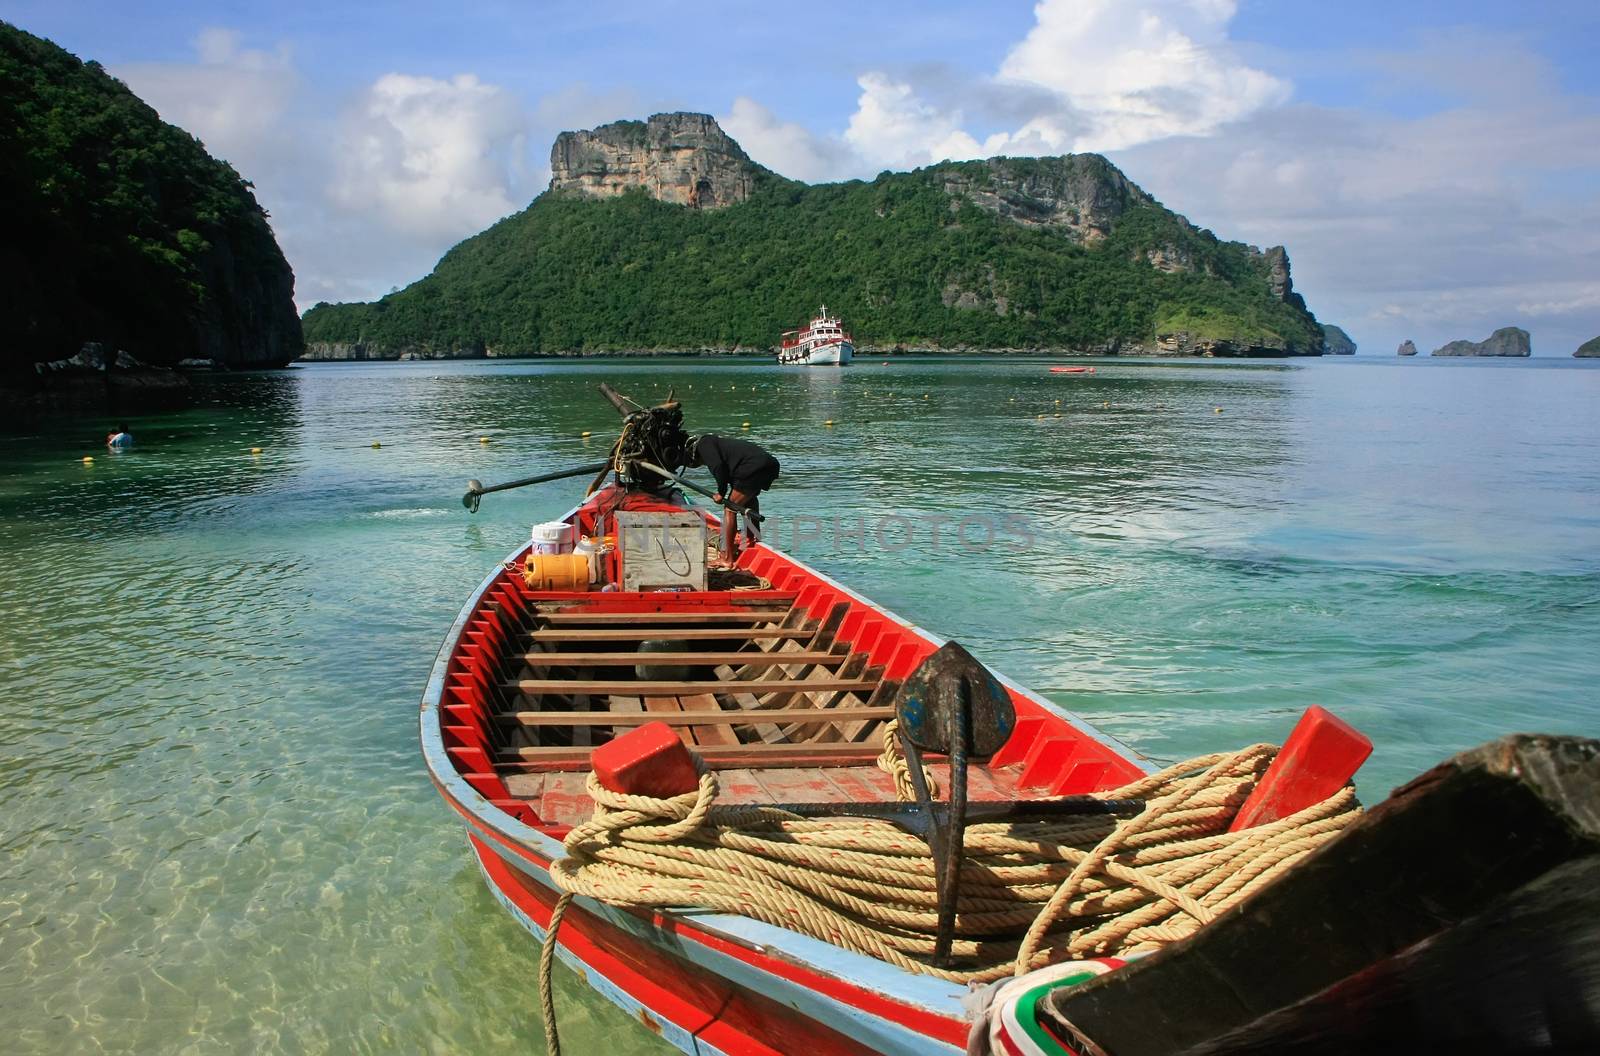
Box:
[1045,734,1600,1056]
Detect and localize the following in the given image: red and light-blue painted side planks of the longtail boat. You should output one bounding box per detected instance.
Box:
[421,489,1150,1056]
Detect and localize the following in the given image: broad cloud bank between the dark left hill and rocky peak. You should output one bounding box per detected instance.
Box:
[114,27,546,307]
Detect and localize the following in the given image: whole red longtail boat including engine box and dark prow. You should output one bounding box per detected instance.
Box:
[421,384,1600,1056]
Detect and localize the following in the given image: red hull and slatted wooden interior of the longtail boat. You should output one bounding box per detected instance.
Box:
[421,485,1149,1056]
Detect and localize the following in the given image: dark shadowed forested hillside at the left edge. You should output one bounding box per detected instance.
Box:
[0,22,302,384]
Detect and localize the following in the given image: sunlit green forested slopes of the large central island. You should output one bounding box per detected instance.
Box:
[304,134,1322,358]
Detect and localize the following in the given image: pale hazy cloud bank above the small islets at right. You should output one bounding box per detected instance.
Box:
[1114,34,1600,354]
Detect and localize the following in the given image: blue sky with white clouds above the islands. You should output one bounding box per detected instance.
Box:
[9,0,1600,355]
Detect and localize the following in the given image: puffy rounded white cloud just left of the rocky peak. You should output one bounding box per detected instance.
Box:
[331,74,526,237]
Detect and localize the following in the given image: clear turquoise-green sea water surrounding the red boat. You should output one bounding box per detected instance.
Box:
[0,358,1600,1056]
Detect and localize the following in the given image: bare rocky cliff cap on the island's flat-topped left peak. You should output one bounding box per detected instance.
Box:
[550,114,771,210]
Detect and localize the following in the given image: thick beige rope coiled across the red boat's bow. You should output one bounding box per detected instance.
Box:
[541,733,1362,1053]
